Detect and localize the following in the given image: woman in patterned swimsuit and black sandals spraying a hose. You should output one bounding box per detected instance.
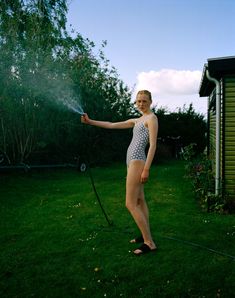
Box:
[81,90,158,255]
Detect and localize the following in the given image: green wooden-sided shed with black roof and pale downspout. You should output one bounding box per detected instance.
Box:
[199,56,235,199]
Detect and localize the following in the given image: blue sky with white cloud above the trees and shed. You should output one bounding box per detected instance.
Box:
[67,0,235,115]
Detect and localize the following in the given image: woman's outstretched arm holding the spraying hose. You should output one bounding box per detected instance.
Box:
[81,114,134,129]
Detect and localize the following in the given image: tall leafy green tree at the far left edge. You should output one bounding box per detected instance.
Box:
[0,0,69,162]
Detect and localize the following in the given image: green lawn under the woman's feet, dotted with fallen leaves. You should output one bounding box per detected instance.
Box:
[0,161,235,298]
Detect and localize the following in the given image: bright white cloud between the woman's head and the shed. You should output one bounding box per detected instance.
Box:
[134,69,207,113]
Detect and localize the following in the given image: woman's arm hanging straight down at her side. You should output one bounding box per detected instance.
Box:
[141,115,158,183]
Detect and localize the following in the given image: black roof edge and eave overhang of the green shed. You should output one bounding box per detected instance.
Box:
[199,56,235,97]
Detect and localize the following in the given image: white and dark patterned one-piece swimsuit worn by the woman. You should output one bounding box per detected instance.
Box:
[126,121,149,166]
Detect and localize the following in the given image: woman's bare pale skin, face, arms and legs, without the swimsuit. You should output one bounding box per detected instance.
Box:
[81,94,158,254]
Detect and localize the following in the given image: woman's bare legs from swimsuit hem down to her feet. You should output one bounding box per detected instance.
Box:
[126,160,156,253]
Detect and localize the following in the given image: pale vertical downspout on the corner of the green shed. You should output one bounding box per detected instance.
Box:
[206,69,221,195]
